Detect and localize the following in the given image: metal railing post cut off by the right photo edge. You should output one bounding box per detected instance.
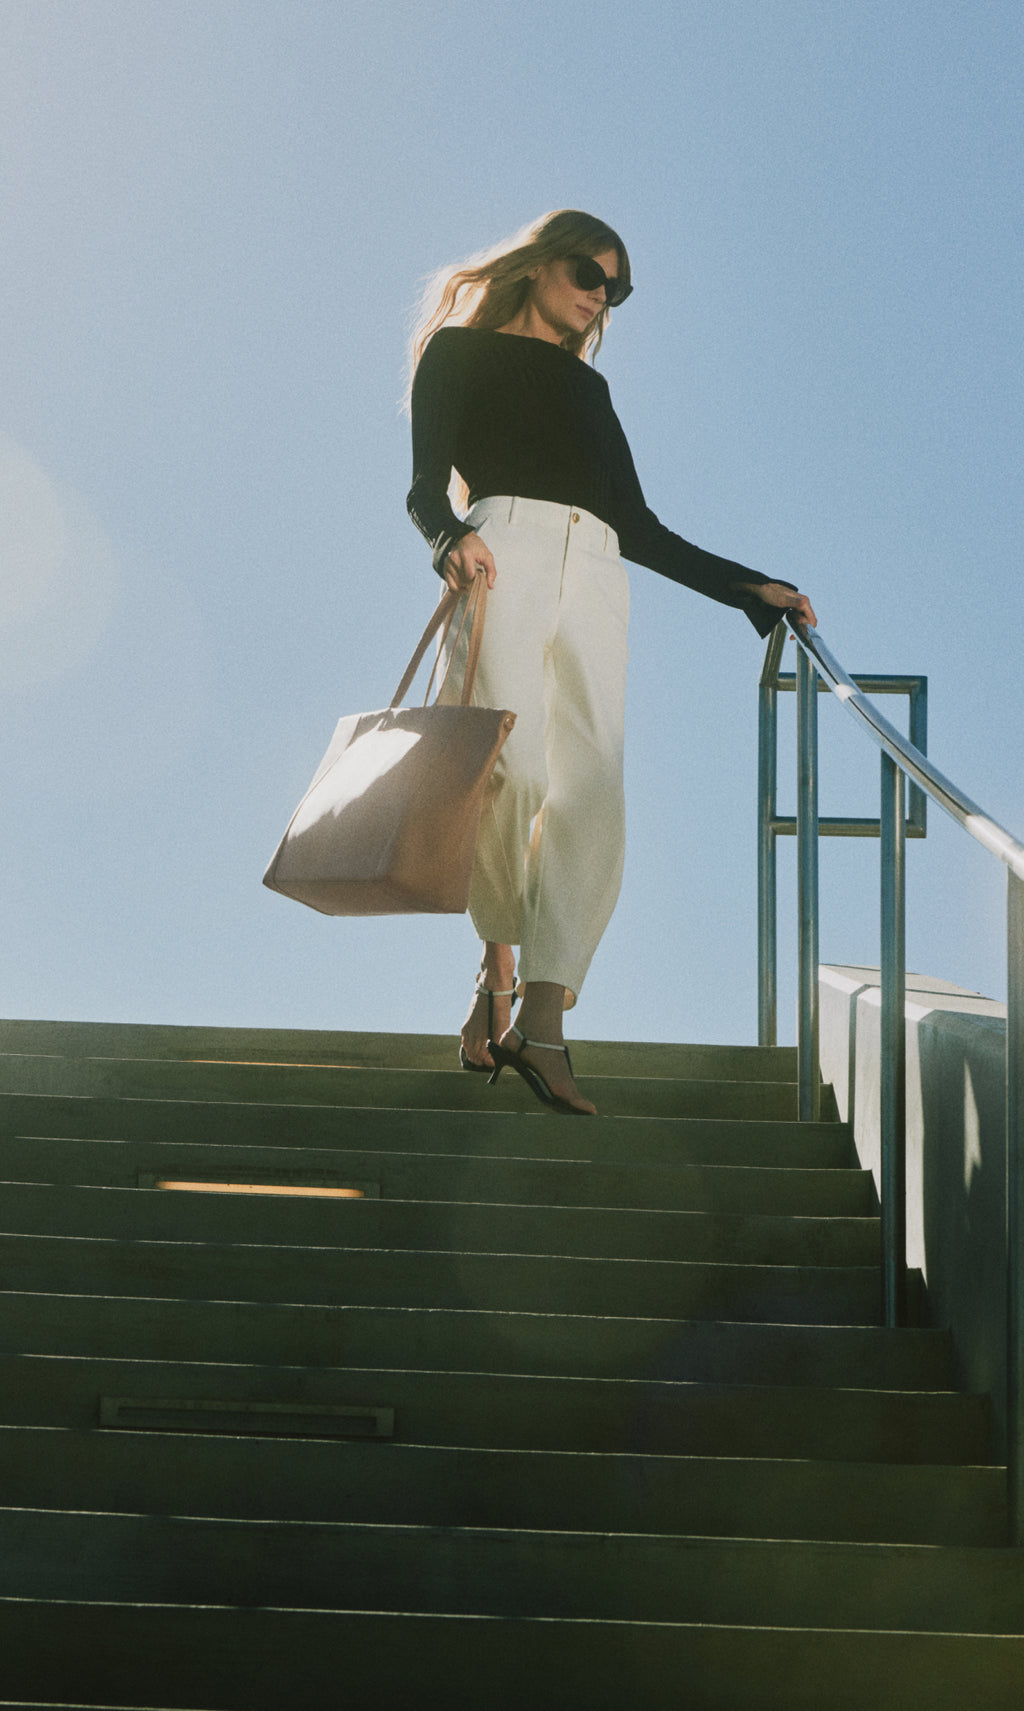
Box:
[1007,867,1024,1545]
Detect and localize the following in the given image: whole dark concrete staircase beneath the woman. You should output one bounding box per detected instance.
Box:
[0,1023,1024,1711]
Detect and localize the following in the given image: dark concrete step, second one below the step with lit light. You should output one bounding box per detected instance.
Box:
[0,1235,882,1324]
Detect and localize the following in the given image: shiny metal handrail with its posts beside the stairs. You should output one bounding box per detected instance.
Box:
[757,623,1024,1545]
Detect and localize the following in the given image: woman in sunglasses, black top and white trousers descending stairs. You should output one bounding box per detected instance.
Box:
[408,209,815,1116]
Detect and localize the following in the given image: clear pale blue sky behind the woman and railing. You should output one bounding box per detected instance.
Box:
[0,0,1024,1040]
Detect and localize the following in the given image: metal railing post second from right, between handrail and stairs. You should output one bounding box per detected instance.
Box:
[880,755,906,1326]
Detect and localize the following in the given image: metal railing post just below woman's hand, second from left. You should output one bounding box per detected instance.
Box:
[796,648,820,1122]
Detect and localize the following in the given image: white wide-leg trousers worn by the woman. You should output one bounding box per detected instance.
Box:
[445,498,628,1009]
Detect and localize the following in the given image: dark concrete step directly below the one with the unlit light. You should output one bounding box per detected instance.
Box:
[0,1427,1005,1545]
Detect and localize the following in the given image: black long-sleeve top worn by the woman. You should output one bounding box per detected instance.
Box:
[408,327,783,636]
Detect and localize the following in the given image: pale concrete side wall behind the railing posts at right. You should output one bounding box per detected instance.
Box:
[819,967,1007,1453]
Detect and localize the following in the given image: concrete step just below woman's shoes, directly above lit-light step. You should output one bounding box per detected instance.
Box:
[0,1076,856,1169]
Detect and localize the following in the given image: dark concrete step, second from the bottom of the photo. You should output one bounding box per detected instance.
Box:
[0,1509,1024,1636]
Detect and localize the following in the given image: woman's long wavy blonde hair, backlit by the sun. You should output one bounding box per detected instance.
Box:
[409,209,630,383]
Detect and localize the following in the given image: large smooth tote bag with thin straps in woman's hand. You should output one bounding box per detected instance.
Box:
[264,577,515,915]
